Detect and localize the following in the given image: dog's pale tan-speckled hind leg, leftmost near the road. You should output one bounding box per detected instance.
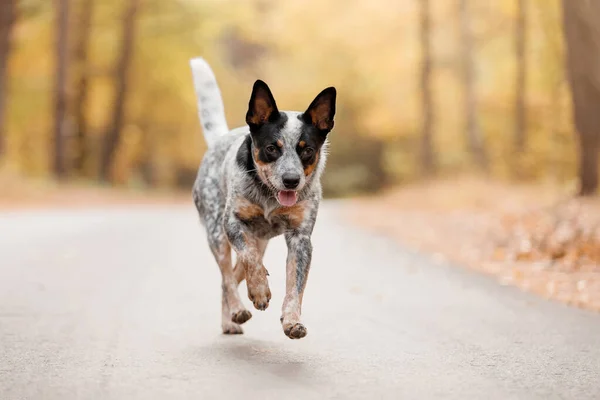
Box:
[213,241,252,334]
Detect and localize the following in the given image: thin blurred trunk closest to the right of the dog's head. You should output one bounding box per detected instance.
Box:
[418,0,436,176]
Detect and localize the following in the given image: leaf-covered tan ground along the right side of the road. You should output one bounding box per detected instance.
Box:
[348,179,600,311]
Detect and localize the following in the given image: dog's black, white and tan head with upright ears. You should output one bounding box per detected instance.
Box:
[246,80,336,207]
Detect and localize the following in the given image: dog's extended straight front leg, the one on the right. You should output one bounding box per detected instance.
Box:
[281,232,312,339]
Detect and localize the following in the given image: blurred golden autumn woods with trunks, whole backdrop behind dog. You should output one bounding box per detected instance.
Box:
[0,0,598,195]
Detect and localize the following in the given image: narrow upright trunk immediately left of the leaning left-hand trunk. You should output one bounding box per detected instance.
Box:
[74,0,94,175]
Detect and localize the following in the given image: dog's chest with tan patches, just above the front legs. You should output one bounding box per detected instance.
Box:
[236,203,305,239]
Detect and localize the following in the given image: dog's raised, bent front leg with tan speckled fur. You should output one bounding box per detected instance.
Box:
[225,214,271,310]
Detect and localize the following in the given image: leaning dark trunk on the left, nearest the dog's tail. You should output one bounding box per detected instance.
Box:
[100,0,140,182]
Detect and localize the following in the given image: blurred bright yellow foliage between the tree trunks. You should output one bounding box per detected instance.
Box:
[1,0,576,188]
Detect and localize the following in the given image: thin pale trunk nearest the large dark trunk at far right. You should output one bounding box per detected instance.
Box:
[514,0,527,153]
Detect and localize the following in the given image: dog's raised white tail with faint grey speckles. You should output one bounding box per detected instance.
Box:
[190,57,229,146]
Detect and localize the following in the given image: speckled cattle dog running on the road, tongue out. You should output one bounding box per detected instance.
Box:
[190,57,337,339]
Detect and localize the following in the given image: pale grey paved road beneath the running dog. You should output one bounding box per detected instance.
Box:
[0,203,600,400]
